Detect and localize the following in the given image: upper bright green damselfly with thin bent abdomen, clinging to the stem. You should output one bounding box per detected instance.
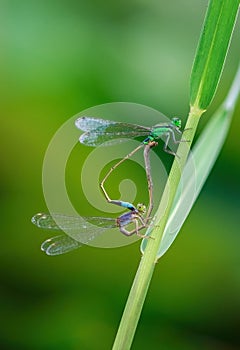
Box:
[75,117,188,203]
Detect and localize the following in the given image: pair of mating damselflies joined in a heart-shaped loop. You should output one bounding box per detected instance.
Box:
[32,117,185,255]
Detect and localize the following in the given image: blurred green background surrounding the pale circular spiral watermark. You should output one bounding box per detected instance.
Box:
[0,0,240,350]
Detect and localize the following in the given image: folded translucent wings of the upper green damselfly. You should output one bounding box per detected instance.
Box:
[75,117,151,147]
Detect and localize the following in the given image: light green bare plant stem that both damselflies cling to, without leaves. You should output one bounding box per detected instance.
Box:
[113,108,204,350]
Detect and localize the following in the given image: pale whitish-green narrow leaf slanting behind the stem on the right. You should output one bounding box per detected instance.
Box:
[141,66,240,258]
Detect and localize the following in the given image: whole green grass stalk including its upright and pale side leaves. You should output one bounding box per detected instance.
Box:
[112,0,239,350]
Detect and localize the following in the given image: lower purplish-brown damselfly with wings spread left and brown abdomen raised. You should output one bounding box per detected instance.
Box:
[32,143,156,255]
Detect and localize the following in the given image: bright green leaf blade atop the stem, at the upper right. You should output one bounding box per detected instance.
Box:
[190,0,239,110]
